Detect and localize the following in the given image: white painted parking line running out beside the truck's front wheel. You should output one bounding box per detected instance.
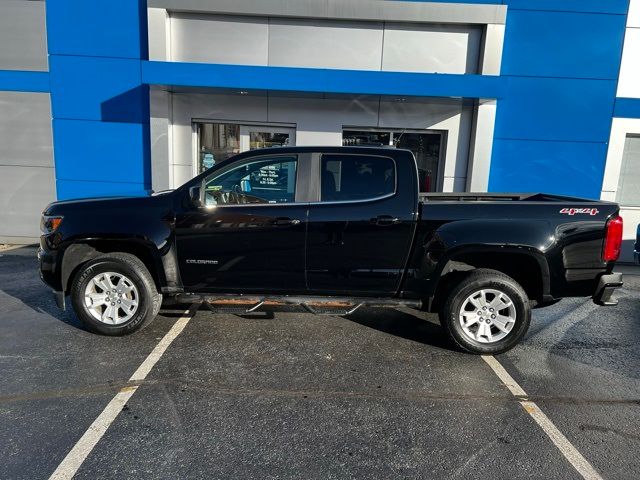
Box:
[49,310,194,480]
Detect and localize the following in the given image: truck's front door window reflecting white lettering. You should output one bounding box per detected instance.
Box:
[204,156,297,206]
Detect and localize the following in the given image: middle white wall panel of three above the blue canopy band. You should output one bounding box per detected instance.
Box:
[269,19,382,70]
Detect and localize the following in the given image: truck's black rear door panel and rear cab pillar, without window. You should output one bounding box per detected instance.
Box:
[307,150,418,296]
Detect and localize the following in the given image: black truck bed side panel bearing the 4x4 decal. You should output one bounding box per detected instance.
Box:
[402,201,618,300]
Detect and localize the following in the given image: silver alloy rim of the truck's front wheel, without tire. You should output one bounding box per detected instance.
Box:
[84,272,140,325]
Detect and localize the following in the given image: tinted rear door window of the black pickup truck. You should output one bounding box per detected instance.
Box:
[320,155,396,202]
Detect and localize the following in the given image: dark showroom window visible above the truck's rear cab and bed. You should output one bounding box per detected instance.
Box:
[342,128,444,192]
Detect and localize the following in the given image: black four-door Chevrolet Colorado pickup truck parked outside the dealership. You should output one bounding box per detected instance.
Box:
[39,147,622,353]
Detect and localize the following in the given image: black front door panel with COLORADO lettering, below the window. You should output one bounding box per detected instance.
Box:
[175,204,307,293]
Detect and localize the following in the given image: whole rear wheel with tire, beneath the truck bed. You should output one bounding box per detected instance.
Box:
[440,269,531,354]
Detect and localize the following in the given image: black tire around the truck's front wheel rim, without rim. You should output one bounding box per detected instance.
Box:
[69,252,162,336]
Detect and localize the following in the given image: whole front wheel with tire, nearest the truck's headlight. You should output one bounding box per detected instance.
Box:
[70,253,162,335]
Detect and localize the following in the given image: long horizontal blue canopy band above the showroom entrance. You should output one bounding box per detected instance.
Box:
[142,61,504,98]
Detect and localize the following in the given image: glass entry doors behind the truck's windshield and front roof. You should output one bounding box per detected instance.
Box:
[193,122,296,176]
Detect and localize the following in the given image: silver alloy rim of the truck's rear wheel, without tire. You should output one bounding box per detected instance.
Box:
[459,288,516,343]
